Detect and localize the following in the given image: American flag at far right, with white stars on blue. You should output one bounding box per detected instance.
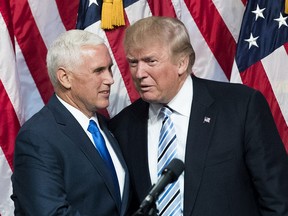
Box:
[236,0,288,148]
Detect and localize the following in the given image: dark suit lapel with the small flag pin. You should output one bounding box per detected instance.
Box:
[184,77,216,215]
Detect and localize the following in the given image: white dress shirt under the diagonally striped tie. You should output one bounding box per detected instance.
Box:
[148,76,193,211]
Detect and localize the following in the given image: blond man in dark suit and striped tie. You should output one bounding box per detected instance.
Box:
[109,17,288,216]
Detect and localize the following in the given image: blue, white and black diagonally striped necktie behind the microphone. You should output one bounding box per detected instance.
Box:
[157,106,182,216]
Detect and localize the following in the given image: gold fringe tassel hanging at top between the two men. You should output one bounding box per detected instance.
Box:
[101,0,125,30]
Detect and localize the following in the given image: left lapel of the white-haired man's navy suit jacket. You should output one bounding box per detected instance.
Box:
[48,95,121,212]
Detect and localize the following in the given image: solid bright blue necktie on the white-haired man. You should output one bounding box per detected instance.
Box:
[87,120,121,201]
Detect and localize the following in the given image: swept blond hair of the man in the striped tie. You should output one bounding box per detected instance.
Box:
[124,16,195,70]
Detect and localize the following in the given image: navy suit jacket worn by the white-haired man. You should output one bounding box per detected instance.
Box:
[11,95,130,216]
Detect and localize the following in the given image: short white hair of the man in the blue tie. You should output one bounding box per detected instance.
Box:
[46,29,104,87]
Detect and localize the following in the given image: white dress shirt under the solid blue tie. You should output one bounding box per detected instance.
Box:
[56,95,125,198]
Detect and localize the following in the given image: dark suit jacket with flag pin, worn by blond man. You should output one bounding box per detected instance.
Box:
[109,76,288,216]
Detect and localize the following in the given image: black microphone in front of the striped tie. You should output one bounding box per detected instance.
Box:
[140,158,184,213]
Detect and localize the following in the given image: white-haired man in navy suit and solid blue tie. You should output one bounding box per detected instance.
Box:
[11,30,130,216]
